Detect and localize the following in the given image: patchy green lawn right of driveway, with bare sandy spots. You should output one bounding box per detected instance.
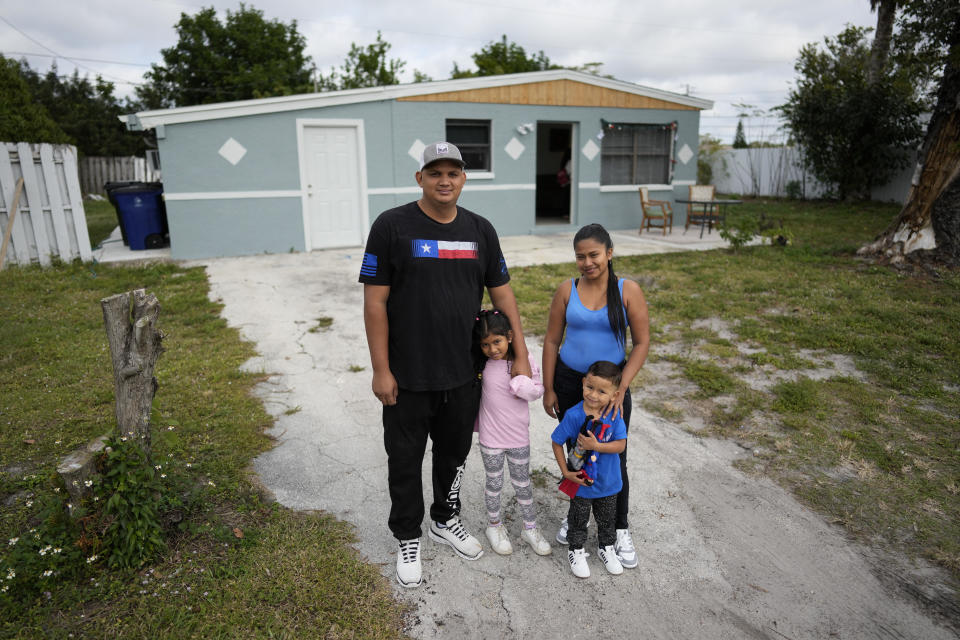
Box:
[512,200,960,578]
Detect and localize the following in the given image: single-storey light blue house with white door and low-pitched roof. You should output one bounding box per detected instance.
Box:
[122,70,713,258]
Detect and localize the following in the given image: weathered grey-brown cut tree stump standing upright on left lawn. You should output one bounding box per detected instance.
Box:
[100,289,163,455]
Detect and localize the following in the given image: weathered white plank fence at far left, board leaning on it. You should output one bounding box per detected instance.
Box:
[0,142,93,265]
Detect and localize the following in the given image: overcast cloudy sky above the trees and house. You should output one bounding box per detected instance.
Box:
[0,0,876,142]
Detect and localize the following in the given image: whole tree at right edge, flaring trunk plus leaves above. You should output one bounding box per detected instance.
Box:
[858,0,960,267]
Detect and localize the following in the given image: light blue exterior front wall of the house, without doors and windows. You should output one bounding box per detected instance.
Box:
[158,95,700,259]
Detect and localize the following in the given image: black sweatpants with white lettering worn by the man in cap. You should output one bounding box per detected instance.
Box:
[383,382,480,540]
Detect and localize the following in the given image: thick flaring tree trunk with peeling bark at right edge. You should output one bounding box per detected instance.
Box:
[857,33,960,266]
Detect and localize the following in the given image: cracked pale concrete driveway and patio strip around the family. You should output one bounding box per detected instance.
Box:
[193,229,955,640]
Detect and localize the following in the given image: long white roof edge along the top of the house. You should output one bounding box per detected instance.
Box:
[120,69,713,131]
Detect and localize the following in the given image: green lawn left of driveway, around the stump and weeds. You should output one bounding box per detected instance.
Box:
[0,264,404,638]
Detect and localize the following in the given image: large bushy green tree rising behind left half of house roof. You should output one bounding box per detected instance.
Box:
[137,3,313,109]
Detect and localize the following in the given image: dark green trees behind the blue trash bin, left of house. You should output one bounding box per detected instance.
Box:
[20,62,144,156]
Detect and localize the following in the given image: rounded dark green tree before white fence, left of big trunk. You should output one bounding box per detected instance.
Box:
[776,26,922,199]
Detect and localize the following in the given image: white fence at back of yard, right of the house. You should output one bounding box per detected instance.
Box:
[710,147,913,202]
